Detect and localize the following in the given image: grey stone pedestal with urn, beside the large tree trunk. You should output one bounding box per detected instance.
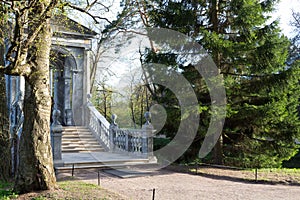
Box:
[51,110,63,167]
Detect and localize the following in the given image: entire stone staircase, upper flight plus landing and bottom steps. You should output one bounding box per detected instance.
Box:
[55,126,156,173]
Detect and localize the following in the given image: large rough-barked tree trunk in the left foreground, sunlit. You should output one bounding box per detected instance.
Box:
[15,12,56,193]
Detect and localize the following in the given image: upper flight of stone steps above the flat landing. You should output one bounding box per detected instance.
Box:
[62,126,104,153]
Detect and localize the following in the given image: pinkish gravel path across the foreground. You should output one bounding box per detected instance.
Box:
[57,167,300,200]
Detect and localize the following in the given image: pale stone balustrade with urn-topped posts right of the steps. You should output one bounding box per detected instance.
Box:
[87,104,153,157]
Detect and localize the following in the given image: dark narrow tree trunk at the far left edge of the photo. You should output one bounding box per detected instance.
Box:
[0,43,11,180]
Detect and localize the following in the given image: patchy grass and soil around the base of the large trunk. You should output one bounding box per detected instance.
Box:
[0,177,124,200]
